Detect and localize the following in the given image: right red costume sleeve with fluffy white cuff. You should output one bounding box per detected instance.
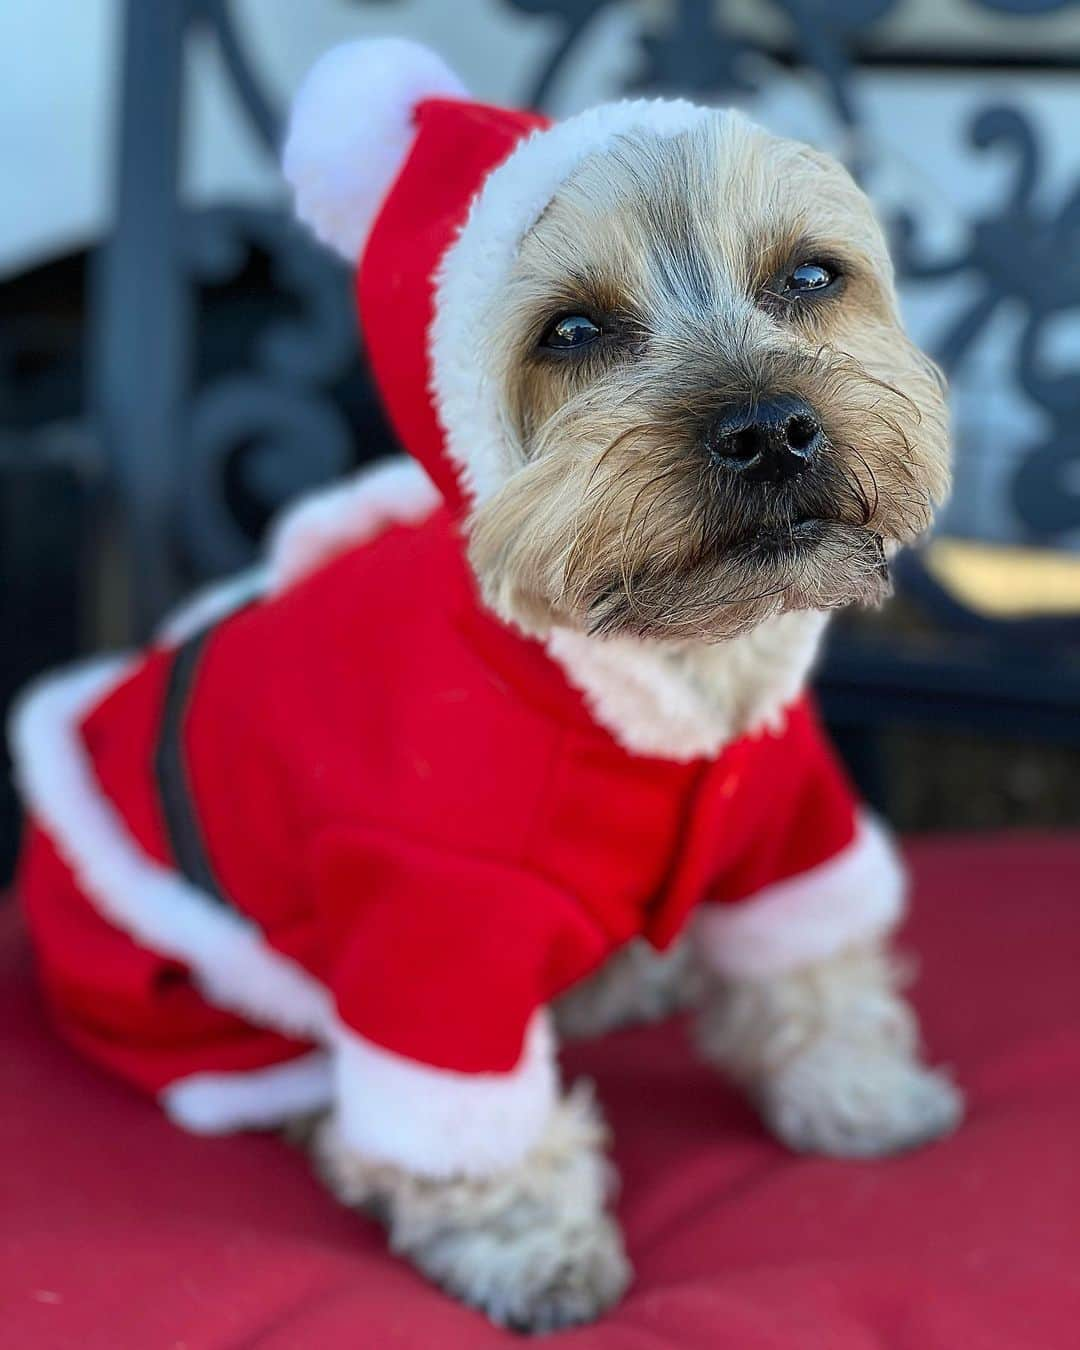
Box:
[697,701,905,979]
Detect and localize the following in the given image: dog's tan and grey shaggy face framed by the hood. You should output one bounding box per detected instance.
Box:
[470,113,948,641]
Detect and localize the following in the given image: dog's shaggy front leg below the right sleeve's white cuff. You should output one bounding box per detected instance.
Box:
[699,946,963,1157]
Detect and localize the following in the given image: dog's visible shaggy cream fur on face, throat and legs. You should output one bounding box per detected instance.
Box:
[315,113,960,1331]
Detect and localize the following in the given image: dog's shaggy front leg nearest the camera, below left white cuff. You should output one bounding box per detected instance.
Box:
[312,1088,630,1331]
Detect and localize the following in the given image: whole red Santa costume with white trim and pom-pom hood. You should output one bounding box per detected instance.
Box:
[14,42,902,1176]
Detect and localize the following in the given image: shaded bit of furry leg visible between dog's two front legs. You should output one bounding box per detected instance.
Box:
[552,938,702,1038]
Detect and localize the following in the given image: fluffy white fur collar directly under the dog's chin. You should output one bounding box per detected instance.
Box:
[547,610,828,763]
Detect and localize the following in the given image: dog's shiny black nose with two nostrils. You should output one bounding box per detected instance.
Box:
[706,397,824,483]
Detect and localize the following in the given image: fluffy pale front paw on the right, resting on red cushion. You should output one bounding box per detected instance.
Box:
[760,1038,964,1158]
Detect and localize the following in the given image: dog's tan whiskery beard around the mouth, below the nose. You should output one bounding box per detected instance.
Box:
[470,446,912,643]
